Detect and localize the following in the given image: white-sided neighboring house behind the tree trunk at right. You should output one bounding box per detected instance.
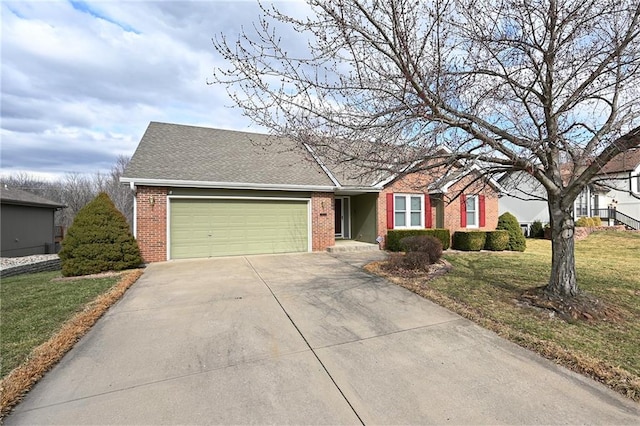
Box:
[499,148,640,233]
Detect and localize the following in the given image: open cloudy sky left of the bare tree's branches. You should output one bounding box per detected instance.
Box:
[0,0,308,179]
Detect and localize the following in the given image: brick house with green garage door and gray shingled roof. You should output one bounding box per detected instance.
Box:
[121,122,499,262]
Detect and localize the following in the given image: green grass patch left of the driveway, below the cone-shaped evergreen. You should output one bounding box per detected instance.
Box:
[0,272,120,377]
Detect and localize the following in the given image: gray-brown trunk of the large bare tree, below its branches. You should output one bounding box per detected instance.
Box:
[546,197,578,297]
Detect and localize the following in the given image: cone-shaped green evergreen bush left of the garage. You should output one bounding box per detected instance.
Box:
[58,192,142,277]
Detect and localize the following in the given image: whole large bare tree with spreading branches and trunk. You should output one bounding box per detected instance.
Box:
[213,0,640,296]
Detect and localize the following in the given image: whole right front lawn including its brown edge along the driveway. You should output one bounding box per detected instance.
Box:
[373,232,640,400]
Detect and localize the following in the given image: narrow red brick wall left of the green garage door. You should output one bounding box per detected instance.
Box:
[136,186,167,263]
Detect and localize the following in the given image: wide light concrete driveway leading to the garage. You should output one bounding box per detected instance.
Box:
[6,252,640,425]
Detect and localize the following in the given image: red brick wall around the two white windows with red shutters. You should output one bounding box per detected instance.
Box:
[378,173,498,248]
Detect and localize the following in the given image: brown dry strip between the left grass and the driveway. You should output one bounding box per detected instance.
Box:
[0,269,143,420]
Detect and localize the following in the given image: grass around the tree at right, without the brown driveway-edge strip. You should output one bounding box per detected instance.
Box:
[438,232,640,376]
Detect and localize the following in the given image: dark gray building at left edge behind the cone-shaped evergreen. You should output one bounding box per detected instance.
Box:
[0,186,65,257]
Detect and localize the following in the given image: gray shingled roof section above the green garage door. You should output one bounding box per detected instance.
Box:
[124,122,333,186]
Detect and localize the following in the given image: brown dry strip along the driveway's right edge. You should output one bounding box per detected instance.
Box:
[365,262,640,402]
